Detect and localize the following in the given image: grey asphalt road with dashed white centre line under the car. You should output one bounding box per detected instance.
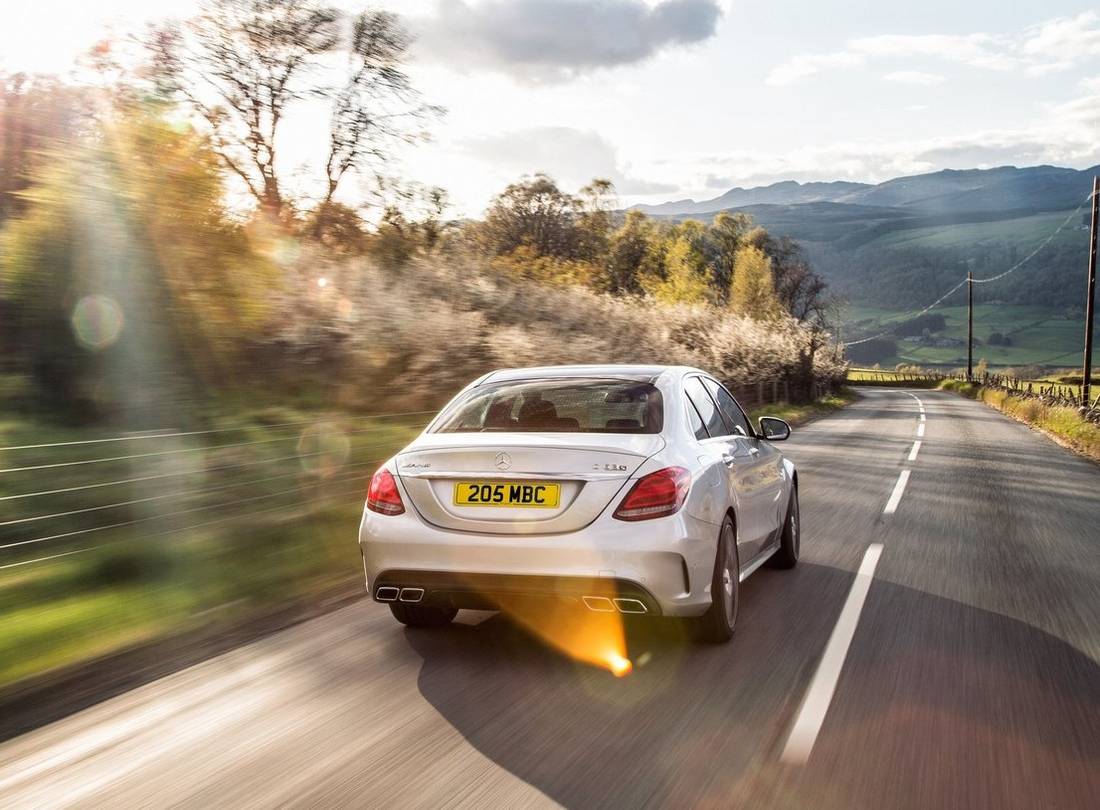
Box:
[0,390,1100,810]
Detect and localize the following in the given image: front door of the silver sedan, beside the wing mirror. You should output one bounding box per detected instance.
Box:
[703,377,783,555]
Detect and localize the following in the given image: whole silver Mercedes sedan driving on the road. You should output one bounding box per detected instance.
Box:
[359,365,800,642]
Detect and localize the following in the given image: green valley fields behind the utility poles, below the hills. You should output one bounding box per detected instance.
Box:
[844,304,1100,369]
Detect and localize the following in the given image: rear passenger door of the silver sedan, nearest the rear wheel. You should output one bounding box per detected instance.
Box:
[684,375,760,565]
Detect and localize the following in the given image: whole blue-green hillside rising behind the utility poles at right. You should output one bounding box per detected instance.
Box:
[638,166,1100,364]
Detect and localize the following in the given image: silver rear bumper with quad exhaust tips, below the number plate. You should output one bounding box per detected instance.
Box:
[359,511,718,616]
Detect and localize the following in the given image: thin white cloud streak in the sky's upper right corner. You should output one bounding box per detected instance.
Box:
[767,11,1100,85]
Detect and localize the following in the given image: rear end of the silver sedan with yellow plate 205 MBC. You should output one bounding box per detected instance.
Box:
[360,374,714,615]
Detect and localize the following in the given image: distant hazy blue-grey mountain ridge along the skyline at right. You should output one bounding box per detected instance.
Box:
[635,166,1100,217]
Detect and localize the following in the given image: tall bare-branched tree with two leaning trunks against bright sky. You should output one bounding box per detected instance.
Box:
[149,0,435,216]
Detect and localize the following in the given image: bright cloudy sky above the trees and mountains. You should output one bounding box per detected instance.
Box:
[0,0,1100,214]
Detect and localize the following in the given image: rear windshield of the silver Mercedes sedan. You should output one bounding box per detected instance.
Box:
[435,380,663,434]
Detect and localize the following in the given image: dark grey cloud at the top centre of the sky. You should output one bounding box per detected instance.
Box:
[413,0,722,83]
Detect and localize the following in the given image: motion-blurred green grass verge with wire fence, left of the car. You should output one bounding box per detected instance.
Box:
[0,413,422,691]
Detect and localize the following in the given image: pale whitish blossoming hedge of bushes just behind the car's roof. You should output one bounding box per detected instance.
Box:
[277,253,845,409]
